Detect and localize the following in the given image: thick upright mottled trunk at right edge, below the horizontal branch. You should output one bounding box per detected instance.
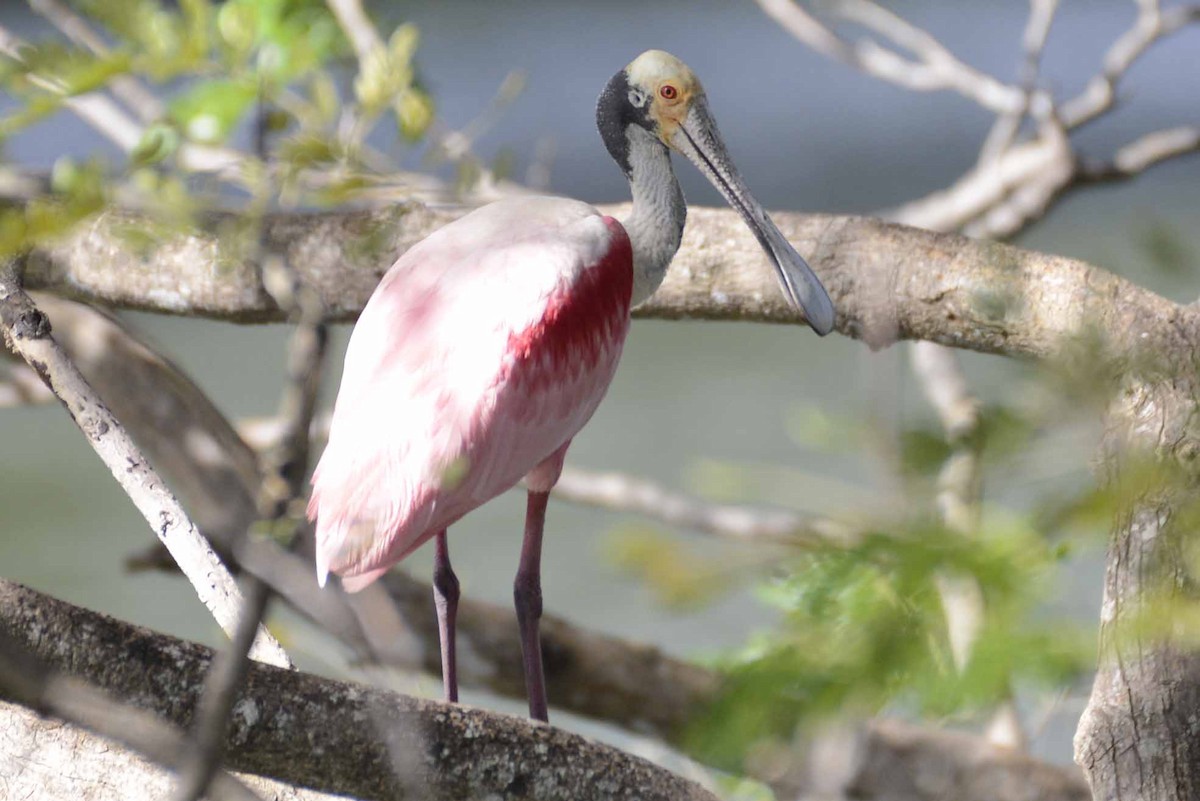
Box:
[1075,379,1200,801]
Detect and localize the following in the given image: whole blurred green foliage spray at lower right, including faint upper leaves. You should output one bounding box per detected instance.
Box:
[610,354,1132,771]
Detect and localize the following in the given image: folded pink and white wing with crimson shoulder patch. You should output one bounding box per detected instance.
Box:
[308,198,632,589]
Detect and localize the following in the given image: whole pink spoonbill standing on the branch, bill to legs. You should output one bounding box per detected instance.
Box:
[307,50,835,721]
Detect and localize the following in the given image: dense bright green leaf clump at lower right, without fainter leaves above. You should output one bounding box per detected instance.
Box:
[691,522,1094,767]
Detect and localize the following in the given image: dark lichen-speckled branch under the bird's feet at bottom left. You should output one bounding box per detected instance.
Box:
[0,582,715,801]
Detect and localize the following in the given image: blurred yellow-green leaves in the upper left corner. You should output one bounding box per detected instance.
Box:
[0,0,433,254]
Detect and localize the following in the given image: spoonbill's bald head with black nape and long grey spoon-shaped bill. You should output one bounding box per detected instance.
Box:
[596,50,834,335]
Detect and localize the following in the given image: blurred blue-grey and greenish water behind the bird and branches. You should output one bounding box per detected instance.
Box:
[0,0,1200,777]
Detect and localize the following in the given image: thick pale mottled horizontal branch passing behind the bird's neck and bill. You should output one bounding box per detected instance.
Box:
[26,203,1200,356]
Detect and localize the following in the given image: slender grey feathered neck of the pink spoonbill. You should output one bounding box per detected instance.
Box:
[622,126,688,306]
